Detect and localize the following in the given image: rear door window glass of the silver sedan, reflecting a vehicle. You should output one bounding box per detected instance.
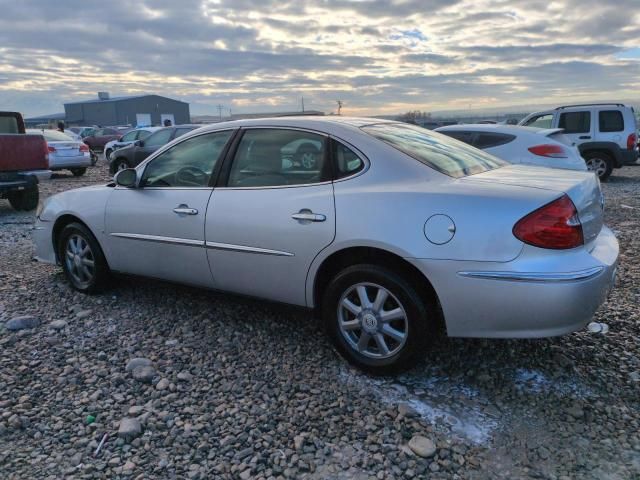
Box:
[227,128,331,187]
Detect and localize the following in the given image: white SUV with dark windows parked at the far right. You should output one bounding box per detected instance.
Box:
[520,103,638,181]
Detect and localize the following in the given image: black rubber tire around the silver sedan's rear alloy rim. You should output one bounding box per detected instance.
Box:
[322,264,437,375]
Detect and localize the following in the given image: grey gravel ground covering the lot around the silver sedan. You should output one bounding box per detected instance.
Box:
[0,159,640,479]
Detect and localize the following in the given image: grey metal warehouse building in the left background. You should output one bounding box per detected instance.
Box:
[64,92,191,127]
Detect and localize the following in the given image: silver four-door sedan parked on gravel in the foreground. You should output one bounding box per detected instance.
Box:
[34,117,618,373]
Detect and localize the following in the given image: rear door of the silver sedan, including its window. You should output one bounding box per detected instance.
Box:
[205,128,335,305]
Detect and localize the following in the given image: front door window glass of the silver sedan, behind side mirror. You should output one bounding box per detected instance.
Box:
[142,130,232,188]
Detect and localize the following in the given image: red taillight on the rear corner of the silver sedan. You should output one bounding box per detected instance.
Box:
[513,194,584,250]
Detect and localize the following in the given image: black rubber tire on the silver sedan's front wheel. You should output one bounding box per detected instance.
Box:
[56,223,111,294]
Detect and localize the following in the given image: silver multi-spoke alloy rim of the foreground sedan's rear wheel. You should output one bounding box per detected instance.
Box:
[338,283,409,359]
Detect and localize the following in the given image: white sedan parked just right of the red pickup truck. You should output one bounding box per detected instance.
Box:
[27,130,91,177]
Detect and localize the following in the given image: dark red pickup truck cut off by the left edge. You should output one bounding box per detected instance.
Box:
[0,112,51,210]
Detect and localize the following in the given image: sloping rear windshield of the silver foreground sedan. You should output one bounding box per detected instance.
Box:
[362,123,508,178]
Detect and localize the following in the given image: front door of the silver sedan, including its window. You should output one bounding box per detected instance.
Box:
[105,130,232,287]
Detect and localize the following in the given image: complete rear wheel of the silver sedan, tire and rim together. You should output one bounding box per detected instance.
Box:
[322,264,436,374]
